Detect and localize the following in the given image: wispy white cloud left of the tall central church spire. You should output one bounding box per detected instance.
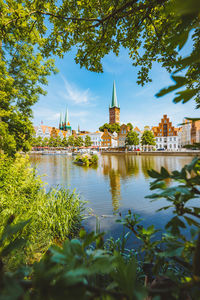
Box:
[60,75,94,104]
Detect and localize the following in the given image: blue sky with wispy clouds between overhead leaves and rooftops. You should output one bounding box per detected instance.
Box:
[33,47,199,132]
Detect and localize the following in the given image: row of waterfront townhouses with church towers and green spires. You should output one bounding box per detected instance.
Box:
[35,82,200,151]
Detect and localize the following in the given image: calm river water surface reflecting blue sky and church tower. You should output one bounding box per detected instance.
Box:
[30,154,192,221]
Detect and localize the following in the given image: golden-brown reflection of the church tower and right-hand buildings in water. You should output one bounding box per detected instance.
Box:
[101,154,191,211]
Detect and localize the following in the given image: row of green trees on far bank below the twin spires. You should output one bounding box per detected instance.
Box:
[32,135,92,147]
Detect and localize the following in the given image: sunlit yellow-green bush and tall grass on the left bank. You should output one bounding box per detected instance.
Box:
[0,155,83,265]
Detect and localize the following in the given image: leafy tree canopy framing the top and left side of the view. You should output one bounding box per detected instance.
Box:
[0,0,200,153]
